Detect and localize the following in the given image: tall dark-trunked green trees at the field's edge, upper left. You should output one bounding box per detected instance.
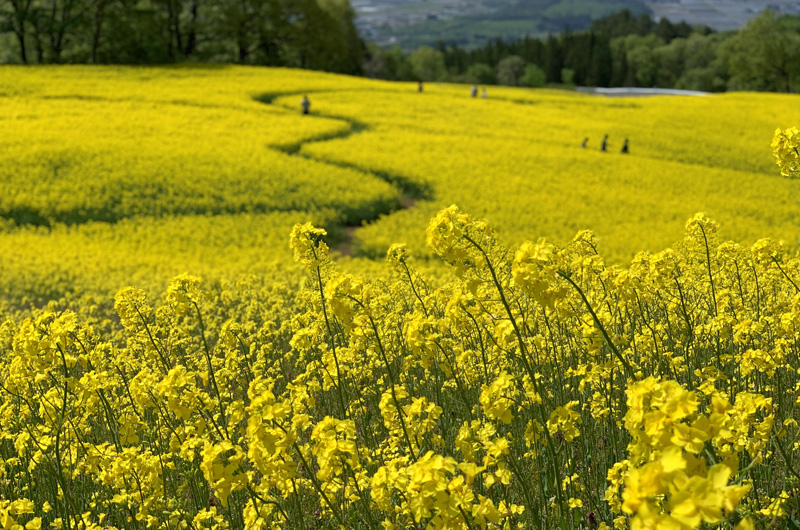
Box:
[0,0,366,74]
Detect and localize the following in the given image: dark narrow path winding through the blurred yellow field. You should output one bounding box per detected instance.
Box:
[253,91,432,256]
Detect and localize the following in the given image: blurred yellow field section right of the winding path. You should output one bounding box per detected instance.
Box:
[292,88,800,262]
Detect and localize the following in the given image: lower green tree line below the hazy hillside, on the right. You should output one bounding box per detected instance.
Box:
[364,11,800,92]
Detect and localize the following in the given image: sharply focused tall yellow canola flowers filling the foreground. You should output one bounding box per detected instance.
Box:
[0,202,800,530]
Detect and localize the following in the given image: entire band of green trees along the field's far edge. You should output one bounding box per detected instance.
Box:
[0,0,800,92]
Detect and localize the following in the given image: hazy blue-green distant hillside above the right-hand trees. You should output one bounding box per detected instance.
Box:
[352,0,800,50]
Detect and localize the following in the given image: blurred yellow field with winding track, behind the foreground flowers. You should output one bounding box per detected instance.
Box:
[0,67,800,300]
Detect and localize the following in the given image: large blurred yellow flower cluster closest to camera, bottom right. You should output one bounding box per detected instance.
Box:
[606,376,772,529]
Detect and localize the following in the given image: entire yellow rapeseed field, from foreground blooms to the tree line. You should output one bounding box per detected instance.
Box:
[0,67,800,530]
